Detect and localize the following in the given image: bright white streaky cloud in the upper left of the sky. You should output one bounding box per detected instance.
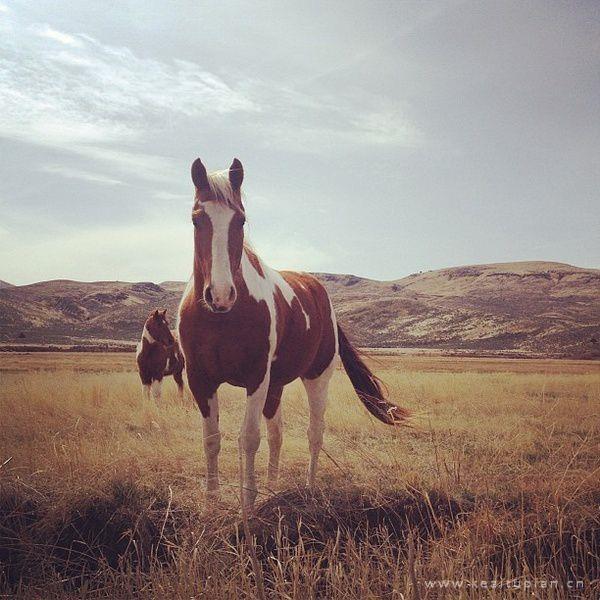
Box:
[0,12,259,179]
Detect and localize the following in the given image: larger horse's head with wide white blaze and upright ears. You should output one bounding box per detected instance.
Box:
[192,158,246,313]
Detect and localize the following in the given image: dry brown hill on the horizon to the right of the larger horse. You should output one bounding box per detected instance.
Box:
[321,262,600,356]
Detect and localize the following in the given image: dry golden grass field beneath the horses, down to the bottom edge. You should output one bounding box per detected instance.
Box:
[0,353,600,599]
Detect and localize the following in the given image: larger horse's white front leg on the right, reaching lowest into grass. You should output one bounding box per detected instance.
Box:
[239,368,270,508]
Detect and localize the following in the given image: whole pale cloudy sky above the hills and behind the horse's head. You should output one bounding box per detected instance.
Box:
[0,0,600,284]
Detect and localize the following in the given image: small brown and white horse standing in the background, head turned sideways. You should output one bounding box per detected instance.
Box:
[136,308,185,401]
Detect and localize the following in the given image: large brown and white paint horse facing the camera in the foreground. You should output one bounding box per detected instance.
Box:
[178,159,408,506]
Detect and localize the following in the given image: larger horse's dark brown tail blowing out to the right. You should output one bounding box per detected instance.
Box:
[337,325,410,425]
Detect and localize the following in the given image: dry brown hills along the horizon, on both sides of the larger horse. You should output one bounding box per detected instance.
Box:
[0,262,600,357]
